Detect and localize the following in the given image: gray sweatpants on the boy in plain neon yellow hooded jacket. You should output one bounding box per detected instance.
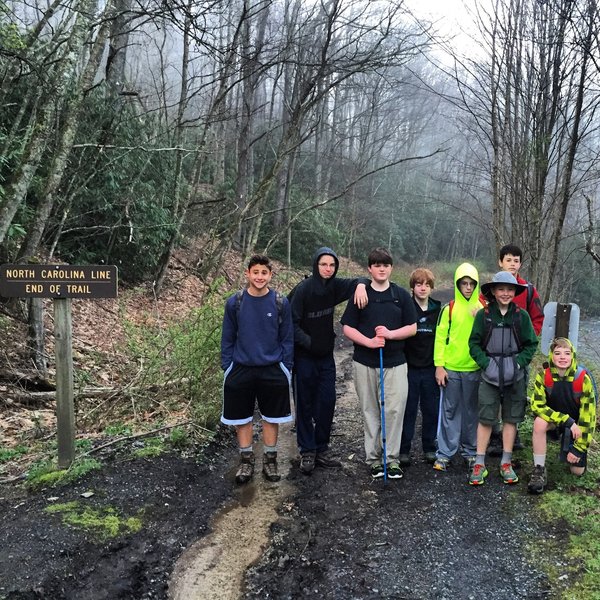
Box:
[437,369,480,460]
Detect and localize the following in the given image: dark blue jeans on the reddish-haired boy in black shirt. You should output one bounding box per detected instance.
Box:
[400,366,440,454]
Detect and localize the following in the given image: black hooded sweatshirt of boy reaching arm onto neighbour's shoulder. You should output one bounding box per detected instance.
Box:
[290,247,369,357]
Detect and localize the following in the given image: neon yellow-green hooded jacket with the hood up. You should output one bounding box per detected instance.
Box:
[433,263,483,371]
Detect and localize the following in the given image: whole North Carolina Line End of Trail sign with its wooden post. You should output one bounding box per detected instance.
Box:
[0,265,117,469]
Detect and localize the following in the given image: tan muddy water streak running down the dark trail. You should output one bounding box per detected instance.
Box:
[169,424,297,600]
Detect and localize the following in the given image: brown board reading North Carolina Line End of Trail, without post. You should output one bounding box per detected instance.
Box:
[0,264,117,298]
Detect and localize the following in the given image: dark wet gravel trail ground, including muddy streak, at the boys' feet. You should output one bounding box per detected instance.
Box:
[0,342,568,600]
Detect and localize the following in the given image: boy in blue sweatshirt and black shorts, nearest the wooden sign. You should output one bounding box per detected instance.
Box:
[221,255,294,484]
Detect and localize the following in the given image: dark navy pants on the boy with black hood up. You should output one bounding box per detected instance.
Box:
[294,354,335,452]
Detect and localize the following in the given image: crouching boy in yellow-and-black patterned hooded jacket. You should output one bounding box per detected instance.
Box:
[527,338,596,494]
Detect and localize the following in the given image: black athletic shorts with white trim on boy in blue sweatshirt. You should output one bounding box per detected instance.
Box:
[221,363,292,425]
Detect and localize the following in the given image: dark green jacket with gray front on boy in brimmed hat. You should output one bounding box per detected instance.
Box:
[469,300,538,387]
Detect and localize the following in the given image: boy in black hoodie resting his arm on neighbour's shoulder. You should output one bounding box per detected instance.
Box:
[291,247,369,474]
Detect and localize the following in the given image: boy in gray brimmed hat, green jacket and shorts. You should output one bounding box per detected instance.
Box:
[469,271,538,485]
